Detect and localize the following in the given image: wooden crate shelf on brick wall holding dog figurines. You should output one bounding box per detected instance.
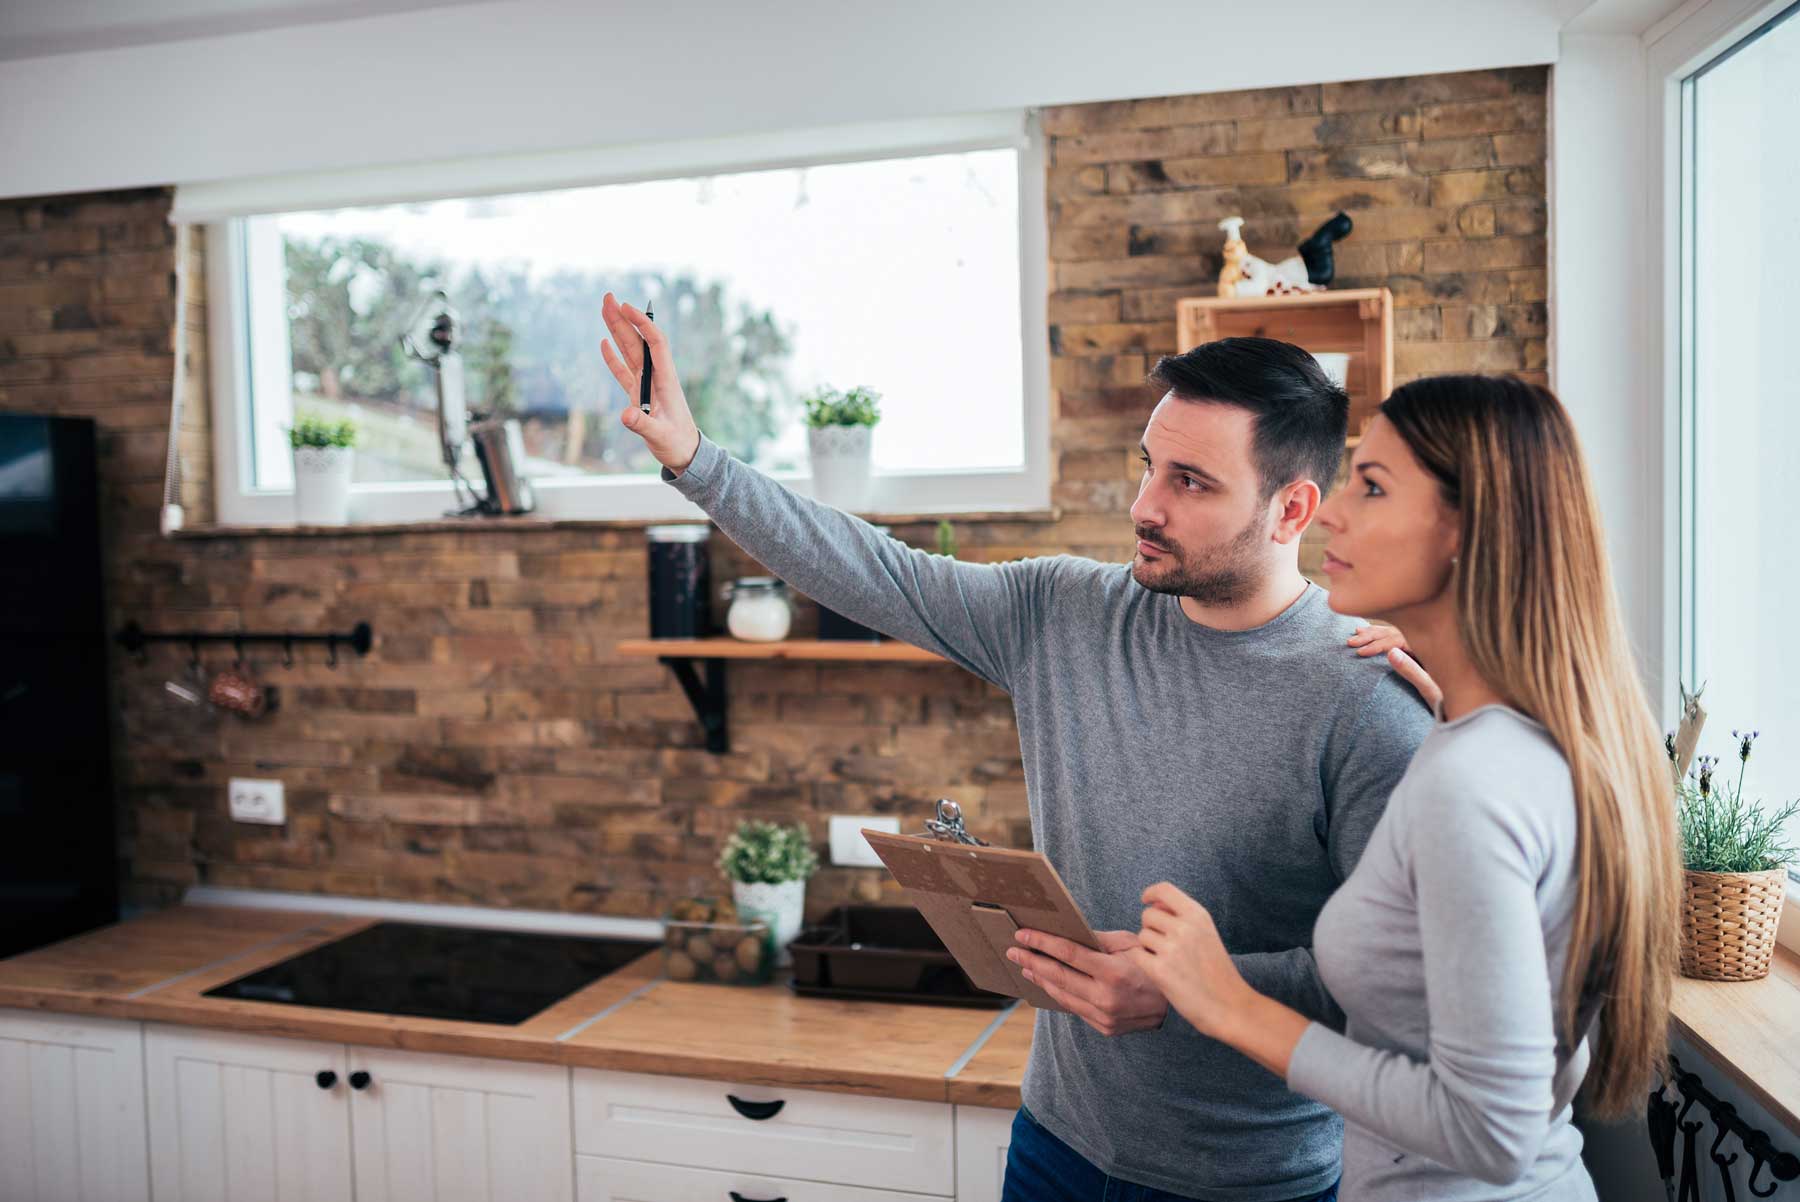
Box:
[1175,288,1393,446]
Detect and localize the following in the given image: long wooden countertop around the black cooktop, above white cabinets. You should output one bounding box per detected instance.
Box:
[0,905,1031,1107]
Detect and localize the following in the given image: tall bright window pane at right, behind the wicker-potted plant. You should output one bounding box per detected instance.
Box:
[1678,5,1800,863]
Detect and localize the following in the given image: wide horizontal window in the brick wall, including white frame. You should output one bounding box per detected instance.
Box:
[176,113,1049,525]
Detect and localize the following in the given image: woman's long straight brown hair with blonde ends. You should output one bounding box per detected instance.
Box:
[1381,376,1681,1116]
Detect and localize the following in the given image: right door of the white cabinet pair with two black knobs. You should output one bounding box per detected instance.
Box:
[349,1047,574,1202]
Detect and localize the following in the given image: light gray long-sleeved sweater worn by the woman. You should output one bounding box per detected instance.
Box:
[1287,705,1595,1202]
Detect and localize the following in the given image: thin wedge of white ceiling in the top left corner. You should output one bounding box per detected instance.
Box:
[0,0,496,61]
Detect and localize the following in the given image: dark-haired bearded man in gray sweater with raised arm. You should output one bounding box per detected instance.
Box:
[601,295,1431,1202]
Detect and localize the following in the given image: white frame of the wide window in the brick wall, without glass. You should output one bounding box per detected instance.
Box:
[200,112,1051,525]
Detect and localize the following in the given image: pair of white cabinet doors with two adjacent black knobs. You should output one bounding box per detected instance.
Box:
[146,1026,574,1202]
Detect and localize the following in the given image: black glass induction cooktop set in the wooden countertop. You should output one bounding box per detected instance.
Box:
[207,923,657,1026]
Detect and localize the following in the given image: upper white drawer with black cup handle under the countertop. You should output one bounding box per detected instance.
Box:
[574,1069,956,1202]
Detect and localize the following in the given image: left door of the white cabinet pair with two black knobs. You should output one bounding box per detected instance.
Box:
[144,1024,351,1202]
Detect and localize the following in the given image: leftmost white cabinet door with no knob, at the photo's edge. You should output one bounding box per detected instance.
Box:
[0,1009,149,1202]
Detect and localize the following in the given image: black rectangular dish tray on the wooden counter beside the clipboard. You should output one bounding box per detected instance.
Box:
[788,905,1012,1009]
